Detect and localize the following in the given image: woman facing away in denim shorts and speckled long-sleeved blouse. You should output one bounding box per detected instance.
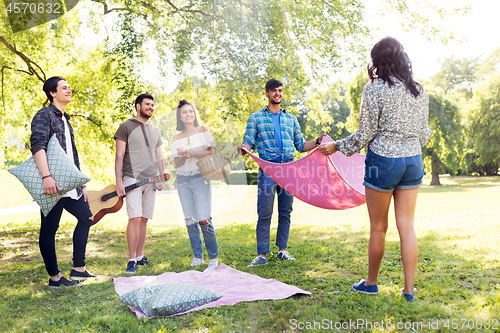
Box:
[319,37,431,302]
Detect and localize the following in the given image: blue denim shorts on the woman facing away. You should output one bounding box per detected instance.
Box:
[363,149,424,192]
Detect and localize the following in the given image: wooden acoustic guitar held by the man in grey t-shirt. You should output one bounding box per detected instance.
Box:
[87,173,170,225]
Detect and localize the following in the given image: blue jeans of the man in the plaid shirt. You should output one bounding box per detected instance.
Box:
[256,168,293,254]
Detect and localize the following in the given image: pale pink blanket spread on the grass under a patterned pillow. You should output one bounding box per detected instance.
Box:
[113,264,311,318]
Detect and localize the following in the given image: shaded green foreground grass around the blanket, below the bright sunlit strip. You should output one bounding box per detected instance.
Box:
[0,219,500,332]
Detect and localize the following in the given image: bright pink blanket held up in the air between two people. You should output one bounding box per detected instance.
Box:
[247,135,365,210]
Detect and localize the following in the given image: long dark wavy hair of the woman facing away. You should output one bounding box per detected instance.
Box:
[367,37,422,97]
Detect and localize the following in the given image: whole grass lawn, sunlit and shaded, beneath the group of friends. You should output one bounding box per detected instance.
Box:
[0,171,500,332]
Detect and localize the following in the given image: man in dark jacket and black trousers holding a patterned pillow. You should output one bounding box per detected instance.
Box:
[30,76,95,289]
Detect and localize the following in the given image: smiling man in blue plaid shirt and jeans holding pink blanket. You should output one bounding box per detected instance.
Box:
[240,79,317,267]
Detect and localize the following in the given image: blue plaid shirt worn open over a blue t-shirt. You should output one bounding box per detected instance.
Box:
[243,106,305,161]
